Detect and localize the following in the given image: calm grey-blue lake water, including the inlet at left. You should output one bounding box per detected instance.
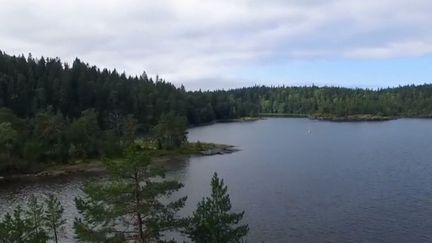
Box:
[0,118,432,242]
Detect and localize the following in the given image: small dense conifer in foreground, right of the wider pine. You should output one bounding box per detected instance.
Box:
[186,173,249,243]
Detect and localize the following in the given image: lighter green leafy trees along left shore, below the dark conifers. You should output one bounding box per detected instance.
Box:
[0,110,132,174]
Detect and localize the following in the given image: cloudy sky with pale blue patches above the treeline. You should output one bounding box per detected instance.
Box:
[0,0,432,90]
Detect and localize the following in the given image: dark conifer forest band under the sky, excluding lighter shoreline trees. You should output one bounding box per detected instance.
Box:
[0,50,432,125]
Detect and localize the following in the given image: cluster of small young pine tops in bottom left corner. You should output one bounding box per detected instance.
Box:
[0,195,65,243]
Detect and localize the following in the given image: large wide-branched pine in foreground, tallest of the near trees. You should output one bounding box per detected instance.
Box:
[74,147,186,242]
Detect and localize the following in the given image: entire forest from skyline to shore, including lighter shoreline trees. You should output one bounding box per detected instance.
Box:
[0,52,432,176]
